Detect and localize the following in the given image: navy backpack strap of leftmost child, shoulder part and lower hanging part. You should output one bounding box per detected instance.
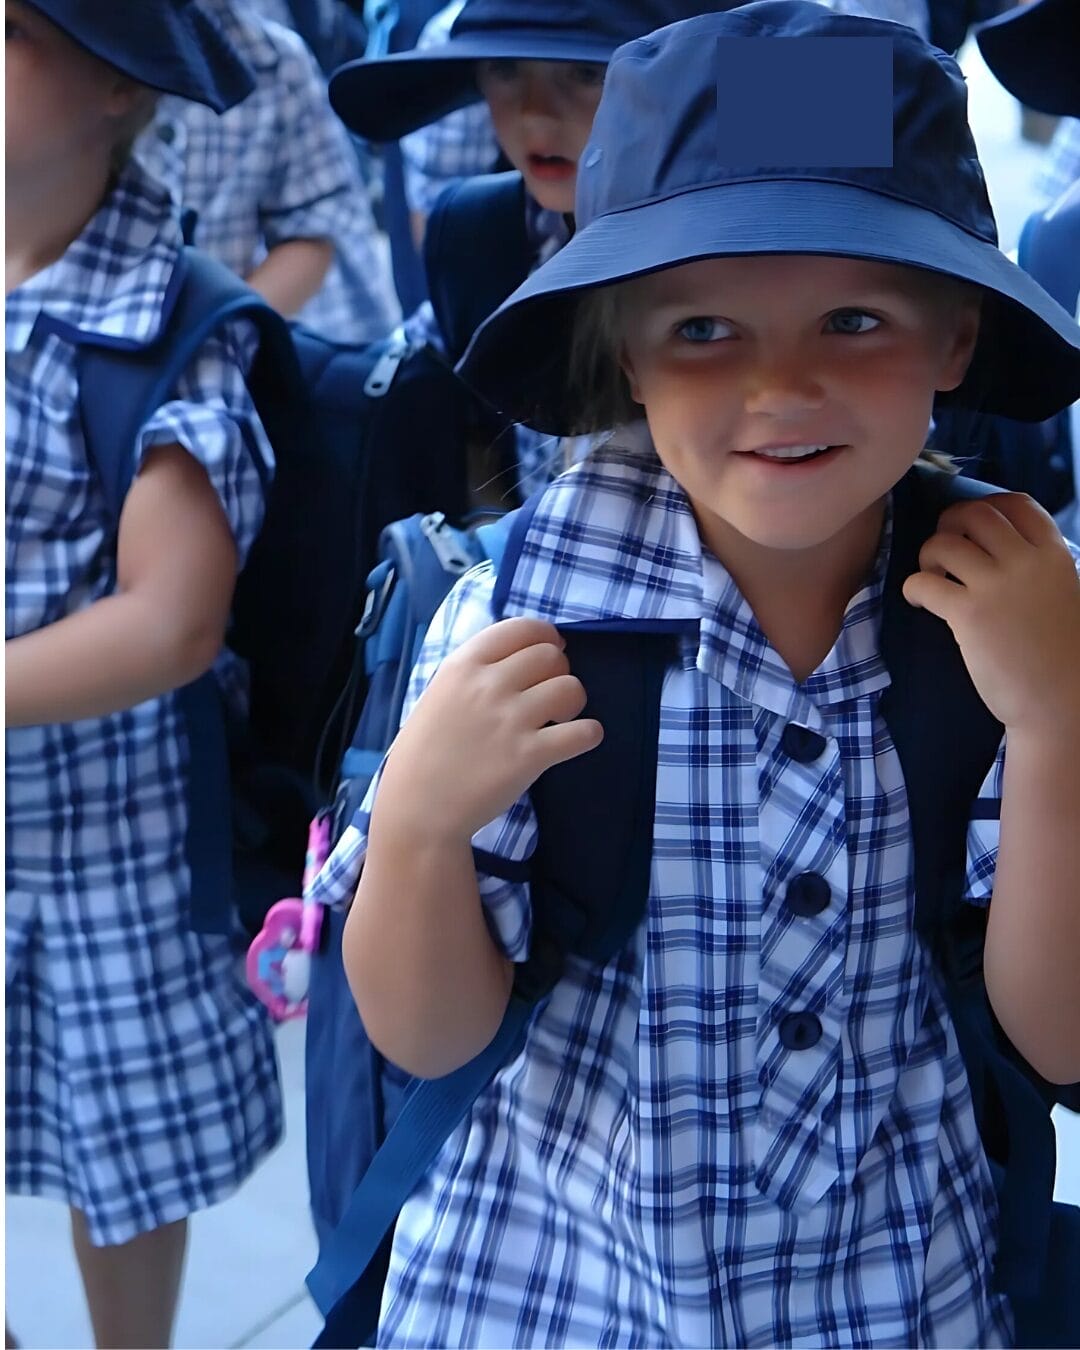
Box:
[78,248,294,933]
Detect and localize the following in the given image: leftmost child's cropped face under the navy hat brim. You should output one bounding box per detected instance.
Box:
[4,0,139,190]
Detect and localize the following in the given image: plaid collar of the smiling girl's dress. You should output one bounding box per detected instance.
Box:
[502,423,892,713]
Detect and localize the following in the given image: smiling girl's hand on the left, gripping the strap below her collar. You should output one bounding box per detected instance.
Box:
[375,618,603,841]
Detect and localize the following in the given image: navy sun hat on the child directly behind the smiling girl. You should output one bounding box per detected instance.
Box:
[329,0,737,140]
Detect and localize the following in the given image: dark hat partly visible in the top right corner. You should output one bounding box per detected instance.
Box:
[975,0,1080,117]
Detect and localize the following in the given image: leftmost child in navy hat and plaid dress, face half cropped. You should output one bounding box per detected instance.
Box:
[5,0,282,1346]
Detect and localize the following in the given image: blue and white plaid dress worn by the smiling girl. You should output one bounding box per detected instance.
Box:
[313,439,1080,1347]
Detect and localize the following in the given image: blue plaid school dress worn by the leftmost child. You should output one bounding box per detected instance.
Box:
[5,153,281,1245]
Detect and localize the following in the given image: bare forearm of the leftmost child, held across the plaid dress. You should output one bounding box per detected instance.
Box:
[4,593,221,726]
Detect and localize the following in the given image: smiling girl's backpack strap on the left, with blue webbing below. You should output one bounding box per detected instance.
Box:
[308,512,672,1346]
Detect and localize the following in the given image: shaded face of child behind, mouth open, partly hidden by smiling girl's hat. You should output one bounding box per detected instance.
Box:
[477,61,605,215]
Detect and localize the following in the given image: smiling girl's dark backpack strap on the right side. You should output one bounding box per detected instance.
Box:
[882,464,1080,1345]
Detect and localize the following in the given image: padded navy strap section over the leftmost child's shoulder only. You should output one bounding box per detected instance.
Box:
[78,248,298,521]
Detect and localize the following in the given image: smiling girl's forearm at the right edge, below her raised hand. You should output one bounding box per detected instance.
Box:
[986,710,1080,1083]
